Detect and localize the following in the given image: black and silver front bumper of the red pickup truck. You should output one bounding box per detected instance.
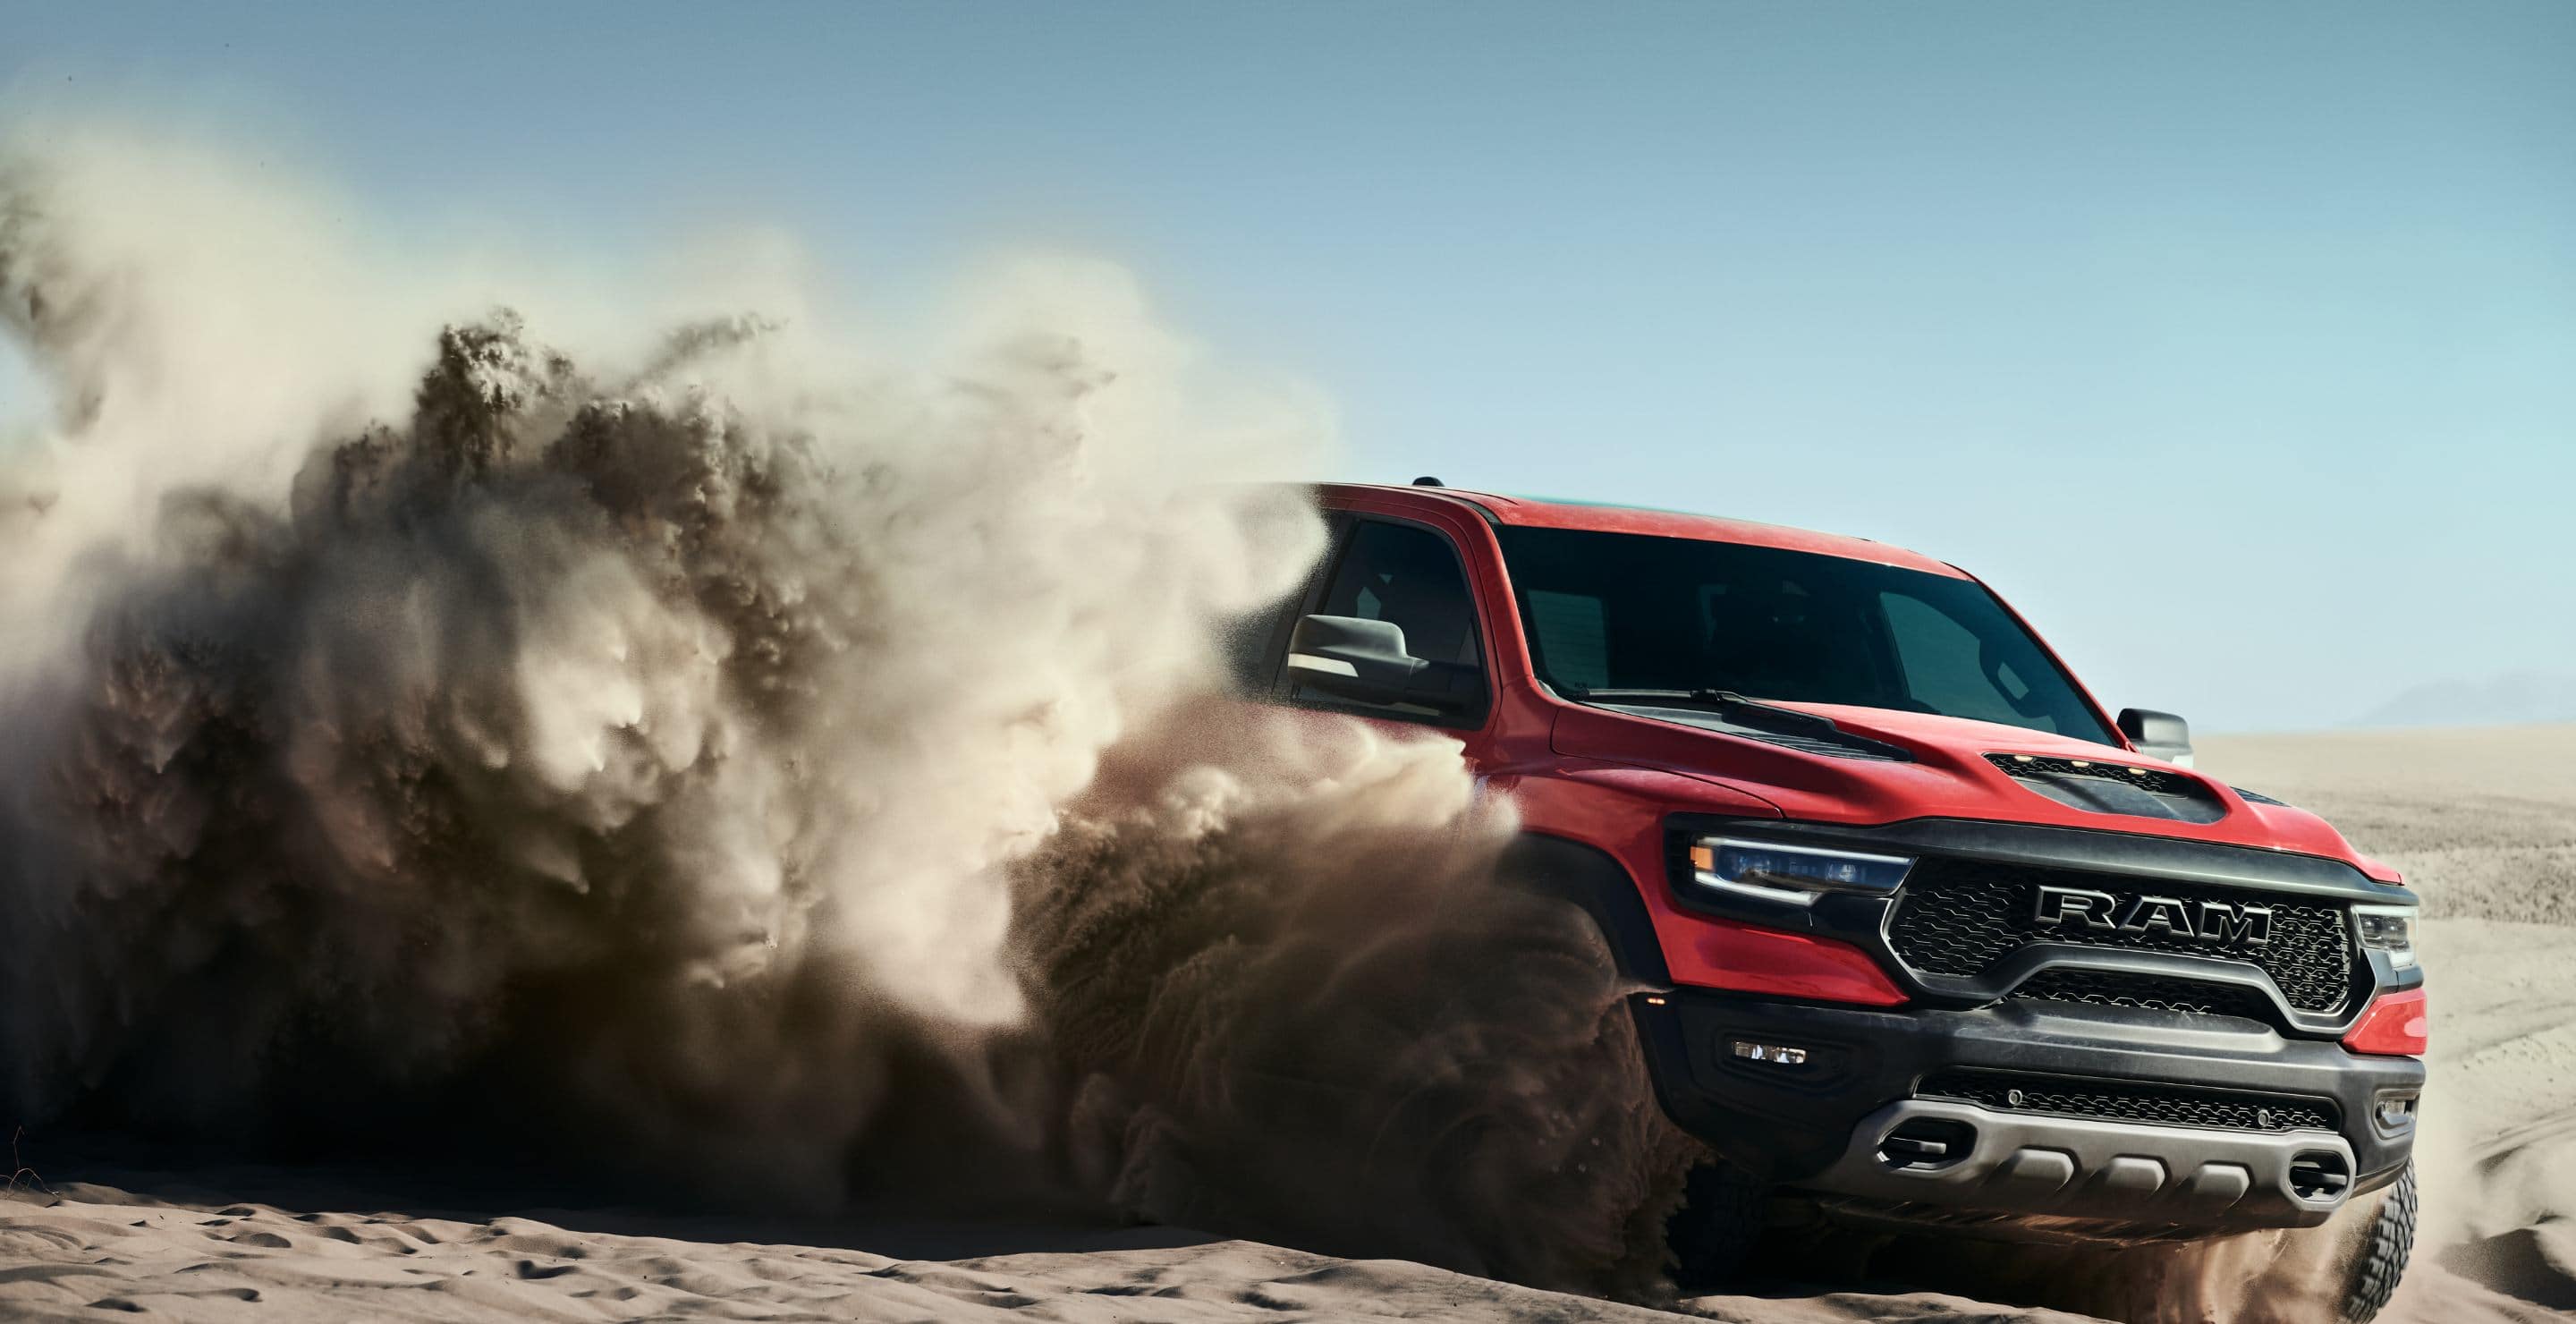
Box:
[1633,989,2424,1228]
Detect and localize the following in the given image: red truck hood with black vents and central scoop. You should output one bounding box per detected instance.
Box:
[1551,703,2398,881]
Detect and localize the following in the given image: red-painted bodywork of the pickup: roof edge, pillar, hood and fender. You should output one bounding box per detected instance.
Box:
[1321,484,2398,987]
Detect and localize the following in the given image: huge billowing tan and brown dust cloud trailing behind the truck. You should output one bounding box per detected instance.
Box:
[0,132,1682,1283]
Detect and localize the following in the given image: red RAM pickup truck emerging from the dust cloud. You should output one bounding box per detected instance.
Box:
[1239,480,2424,1319]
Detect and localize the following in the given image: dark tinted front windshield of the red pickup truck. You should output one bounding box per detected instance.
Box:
[1496,528,2117,744]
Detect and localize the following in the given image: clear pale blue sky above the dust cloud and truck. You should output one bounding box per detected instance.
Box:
[0,0,2576,729]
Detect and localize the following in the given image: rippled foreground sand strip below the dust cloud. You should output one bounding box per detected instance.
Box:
[0,1169,2073,1324]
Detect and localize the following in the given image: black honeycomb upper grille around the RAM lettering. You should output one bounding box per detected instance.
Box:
[1888,855,2351,1013]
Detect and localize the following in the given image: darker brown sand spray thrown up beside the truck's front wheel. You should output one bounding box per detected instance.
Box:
[1025,711,1698,1293]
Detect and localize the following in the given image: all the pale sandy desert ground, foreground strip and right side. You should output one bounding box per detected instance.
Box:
[0,726,2576,1324]
